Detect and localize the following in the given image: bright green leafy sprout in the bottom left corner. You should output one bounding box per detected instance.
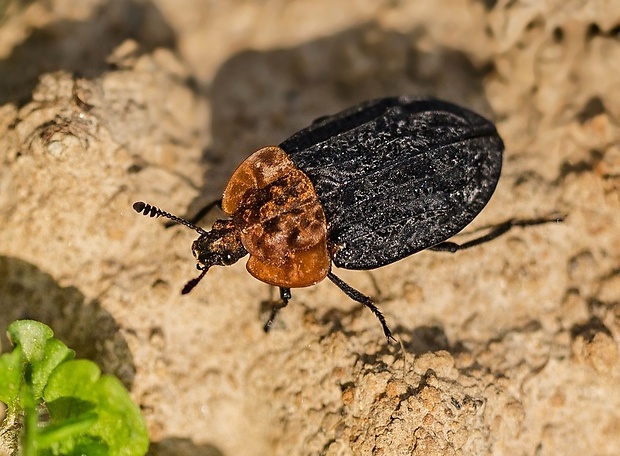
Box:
[0,320,149,456]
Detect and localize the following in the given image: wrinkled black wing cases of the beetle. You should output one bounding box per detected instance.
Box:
[280,97,504,269]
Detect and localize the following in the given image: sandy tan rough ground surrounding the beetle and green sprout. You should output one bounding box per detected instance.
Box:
[0,0,620,456]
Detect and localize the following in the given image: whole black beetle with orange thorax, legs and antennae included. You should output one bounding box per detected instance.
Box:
[133,96,559,340]
